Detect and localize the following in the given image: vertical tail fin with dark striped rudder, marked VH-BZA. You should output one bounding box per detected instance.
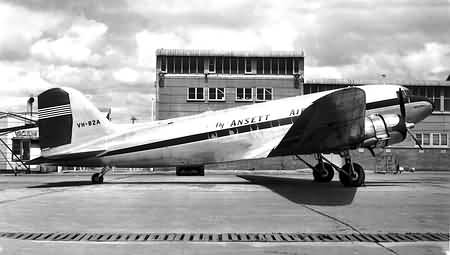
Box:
[38,88,112,149]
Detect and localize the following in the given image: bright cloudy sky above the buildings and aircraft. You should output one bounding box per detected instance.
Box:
[0,0,450,122]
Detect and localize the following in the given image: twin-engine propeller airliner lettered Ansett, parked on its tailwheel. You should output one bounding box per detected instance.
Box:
[10,85,433,187]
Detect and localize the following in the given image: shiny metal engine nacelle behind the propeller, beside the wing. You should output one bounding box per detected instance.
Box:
[361,114,407,148]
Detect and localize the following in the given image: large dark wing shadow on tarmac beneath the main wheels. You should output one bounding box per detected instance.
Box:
[238,175,357,206]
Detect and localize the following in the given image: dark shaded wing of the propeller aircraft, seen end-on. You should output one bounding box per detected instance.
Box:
[269,87,366,157]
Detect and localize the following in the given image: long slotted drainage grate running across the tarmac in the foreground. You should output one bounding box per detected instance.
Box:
[0,232,449,243]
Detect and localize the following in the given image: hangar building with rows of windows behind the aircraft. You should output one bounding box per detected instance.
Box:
[156,49,450,170]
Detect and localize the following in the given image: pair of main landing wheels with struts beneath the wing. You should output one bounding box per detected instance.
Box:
[295,151,365,187]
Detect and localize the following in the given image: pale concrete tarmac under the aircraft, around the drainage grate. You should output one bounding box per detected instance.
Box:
[0,171,450,254]
